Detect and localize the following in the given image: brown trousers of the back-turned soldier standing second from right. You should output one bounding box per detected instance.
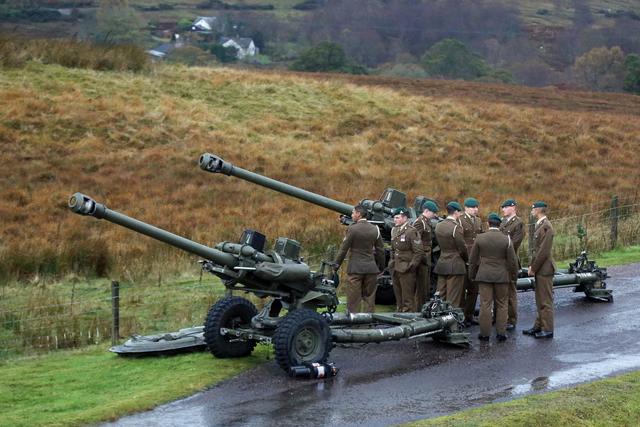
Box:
[478,282,509,337]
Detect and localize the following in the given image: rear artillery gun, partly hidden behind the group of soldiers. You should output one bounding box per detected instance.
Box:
[200,153,613,304]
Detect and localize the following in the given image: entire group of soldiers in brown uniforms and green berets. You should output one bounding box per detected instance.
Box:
[334,197,556,341]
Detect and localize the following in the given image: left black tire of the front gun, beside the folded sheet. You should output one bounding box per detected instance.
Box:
[204,297,258,359]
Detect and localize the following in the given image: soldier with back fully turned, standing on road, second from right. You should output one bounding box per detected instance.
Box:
[469,213,518,341]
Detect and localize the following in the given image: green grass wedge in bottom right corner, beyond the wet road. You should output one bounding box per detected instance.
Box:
[406,372,640,427]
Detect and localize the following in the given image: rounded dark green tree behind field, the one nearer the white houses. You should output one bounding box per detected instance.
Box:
[290,41,367,74]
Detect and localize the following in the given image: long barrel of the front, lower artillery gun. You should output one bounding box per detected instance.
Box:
[69,193,238,268]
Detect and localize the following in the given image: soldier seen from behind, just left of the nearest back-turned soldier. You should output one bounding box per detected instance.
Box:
[433,202,469,308]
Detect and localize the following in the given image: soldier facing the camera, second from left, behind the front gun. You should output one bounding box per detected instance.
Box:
[389,208,424,312]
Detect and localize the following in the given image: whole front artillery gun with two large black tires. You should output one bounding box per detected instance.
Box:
[68,193,468,371]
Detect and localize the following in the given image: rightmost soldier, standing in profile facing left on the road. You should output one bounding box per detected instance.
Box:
[522,202,556,338]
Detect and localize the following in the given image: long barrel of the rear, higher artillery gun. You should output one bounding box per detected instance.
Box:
[200,153,356,216]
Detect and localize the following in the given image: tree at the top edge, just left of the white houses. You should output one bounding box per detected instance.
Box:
[96,0,142,44]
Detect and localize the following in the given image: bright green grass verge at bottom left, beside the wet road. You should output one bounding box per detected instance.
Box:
[0,345,271,427]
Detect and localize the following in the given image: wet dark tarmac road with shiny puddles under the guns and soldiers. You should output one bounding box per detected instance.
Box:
[105,264,640,426]
